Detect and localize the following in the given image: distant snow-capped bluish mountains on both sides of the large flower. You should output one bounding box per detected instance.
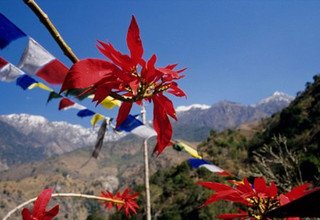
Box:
[0,92,293,170]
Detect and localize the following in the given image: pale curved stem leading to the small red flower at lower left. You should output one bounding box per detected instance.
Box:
[2,193,124,220]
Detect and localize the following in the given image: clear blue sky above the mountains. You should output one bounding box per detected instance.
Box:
[0,0,320,126]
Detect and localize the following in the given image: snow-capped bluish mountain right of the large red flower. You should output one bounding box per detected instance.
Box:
[174,92,293,141]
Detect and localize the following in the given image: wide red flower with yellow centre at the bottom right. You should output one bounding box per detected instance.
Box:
[198,177,310,220]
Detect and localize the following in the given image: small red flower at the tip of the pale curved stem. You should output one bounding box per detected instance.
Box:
[101,189,139,216]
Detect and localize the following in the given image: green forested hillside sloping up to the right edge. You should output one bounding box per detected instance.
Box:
[130,76,320,219]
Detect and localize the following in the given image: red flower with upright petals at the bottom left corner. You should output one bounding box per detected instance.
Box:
[22,189,59,220]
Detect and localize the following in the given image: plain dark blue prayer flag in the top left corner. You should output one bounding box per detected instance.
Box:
[0,13,26,49]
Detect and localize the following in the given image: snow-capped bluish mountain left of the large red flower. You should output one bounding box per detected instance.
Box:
[0,114,123,168]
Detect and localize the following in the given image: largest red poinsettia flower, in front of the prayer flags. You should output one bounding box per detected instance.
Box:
[61,16,185,154]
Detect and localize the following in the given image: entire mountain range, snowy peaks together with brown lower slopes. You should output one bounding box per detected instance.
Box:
[0,93,292,219]
